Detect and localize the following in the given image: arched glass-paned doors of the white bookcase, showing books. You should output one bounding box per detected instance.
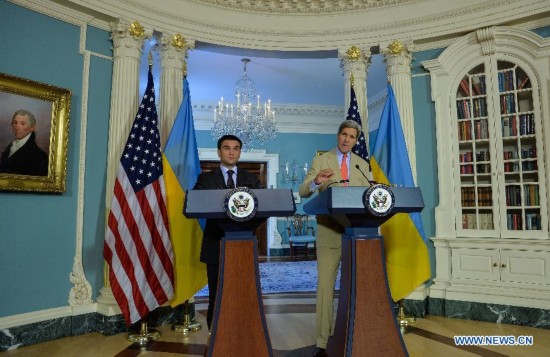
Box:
[458,59,547,238]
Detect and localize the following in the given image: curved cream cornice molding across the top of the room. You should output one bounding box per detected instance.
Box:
[13,0,550,51]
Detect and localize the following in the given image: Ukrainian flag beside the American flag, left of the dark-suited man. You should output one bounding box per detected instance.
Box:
[162,79,207,307]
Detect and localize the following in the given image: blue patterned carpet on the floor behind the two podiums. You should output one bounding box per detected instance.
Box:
[195,260,340,296]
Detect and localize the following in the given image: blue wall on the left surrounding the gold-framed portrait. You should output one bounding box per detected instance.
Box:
[0,0,112,317]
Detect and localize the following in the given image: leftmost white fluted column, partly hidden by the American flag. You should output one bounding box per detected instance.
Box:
[97,19,145,313]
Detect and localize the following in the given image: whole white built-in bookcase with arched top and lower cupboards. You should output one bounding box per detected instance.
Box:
[422,27,550,310]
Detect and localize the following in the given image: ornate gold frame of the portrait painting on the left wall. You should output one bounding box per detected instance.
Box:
[0,73,71,192]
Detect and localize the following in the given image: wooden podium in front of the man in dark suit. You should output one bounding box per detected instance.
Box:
[184,189,296,357]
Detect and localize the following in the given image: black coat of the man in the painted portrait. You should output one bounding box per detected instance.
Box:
[0,133,48,176]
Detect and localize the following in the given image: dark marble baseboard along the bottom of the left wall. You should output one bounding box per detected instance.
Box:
[0,303,195,352]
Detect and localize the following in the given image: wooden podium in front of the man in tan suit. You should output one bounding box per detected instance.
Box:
[304,187,424,357]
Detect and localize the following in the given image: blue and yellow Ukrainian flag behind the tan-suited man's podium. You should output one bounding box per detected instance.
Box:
[371,83,431,301]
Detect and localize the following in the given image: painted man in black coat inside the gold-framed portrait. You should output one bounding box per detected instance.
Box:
[0,109,48,176]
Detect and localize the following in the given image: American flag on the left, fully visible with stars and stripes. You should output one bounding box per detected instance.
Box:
[103,69,174,325]
